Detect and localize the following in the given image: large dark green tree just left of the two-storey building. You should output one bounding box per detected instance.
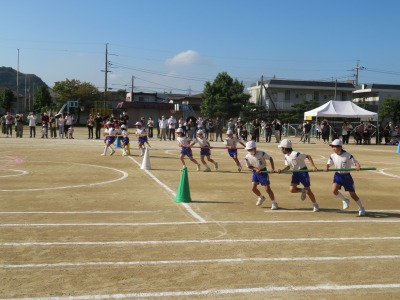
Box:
[200,72,250,118]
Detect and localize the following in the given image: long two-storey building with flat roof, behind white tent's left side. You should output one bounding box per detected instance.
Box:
[248,79,356,111]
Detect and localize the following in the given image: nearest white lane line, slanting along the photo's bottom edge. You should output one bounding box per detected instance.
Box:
[0,283,400,300]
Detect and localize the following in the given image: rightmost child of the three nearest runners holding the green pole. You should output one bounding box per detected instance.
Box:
[324,139,365,216]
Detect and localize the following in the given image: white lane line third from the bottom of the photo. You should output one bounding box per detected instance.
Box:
[0,236,400,247]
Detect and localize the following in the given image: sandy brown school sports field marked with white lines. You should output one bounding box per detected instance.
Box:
[0,128,400,300]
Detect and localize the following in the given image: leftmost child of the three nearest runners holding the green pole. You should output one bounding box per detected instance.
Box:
[244,141,279,210]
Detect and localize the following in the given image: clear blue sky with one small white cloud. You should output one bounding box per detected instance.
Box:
[0,0,400,94]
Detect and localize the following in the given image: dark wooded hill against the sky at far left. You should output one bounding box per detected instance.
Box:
[0,67,48,94]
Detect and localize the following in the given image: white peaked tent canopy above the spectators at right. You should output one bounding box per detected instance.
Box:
[304,100,378,121]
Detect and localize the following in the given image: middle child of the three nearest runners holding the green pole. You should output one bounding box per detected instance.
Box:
[277,139,319,212]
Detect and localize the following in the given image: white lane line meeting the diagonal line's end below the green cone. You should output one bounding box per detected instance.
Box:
[0,218,400,227]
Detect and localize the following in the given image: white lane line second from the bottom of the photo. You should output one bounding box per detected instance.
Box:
[0,255,400,269]
